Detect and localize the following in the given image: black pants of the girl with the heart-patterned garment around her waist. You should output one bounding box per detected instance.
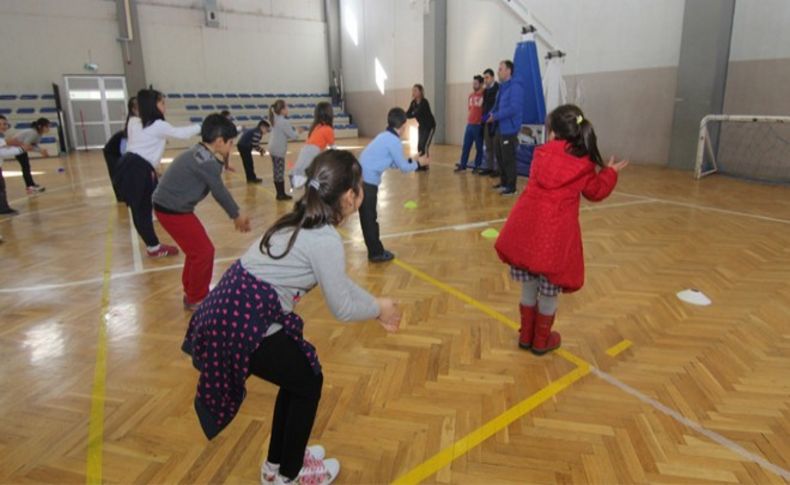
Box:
[250,330,324,479]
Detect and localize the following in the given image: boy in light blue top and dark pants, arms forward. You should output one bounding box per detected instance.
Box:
[359,108,427,263]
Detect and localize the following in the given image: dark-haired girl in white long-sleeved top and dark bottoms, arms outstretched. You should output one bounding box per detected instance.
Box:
[115,89,200,258]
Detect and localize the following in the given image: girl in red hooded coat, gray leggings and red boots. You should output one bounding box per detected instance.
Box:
[495,104,628,355]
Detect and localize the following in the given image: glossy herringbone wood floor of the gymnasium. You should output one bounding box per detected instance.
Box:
[0,140,790,483]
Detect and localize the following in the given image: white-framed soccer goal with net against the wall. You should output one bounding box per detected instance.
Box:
[694,115,790,184]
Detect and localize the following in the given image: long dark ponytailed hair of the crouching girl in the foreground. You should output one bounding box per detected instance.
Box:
[259,150,362,259]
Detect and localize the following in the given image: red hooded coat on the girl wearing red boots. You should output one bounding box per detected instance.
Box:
[494,140,617,292]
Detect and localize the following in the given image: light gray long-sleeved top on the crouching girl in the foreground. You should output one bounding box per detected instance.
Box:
[241,225,380,322]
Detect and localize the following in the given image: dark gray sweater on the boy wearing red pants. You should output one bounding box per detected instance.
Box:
[153,143,239,219]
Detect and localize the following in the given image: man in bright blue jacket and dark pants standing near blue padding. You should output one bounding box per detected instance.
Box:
[486,61,524,195]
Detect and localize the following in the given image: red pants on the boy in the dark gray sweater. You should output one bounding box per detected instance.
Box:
[155,211,214,304]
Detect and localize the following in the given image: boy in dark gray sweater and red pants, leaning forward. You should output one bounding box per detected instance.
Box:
[153,114,250,311]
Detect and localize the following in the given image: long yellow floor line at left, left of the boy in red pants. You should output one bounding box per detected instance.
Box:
[86,207,117,484]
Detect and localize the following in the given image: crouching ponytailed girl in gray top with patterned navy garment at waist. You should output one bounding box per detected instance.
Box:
[182,150,401,485]
